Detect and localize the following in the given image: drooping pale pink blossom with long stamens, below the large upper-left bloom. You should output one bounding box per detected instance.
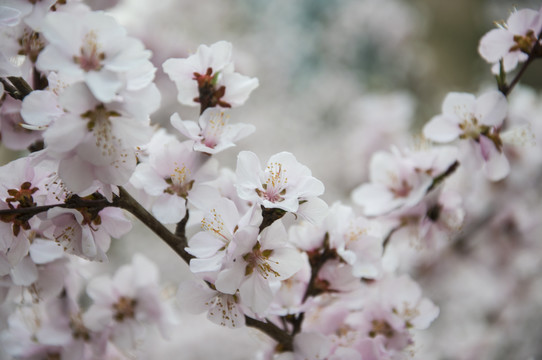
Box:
[44,83,155,193]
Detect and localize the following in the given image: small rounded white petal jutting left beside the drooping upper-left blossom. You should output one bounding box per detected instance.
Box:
[21,90,64,126]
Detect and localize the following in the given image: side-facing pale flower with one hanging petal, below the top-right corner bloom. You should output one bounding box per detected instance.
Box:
[423,91,510,181]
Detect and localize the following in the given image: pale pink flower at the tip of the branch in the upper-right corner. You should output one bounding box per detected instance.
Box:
[478,9,542,74]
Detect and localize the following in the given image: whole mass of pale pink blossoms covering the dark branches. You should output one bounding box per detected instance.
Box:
[0,0,542,360]
